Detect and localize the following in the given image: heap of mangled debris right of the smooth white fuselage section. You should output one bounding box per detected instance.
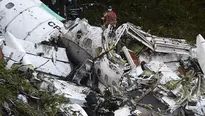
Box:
[61,19,204,115]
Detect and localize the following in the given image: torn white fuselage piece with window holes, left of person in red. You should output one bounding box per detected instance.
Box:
[64,19,105,59]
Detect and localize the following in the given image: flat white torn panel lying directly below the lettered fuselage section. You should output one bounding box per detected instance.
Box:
[3,32,71,77]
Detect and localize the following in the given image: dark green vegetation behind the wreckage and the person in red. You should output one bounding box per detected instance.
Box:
[80,0,205,43]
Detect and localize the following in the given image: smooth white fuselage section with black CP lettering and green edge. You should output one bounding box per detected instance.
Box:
[0,0,66,43]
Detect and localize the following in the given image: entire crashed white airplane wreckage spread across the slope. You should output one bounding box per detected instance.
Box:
[0,0,205,116]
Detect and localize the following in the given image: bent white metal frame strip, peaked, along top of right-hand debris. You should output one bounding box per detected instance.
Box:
[113,23,191,55]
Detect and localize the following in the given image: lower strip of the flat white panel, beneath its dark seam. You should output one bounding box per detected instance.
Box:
[3,46,71,77]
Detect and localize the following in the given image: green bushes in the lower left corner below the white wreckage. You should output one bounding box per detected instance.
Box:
[0,61,68,116]
